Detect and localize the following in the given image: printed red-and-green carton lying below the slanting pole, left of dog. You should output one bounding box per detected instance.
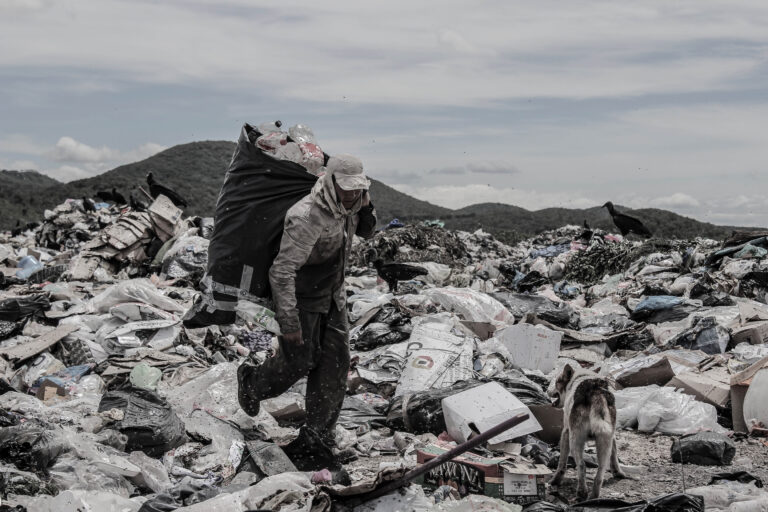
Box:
[416,444,552,505]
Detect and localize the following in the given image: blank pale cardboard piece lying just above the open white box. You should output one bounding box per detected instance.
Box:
[494,324,563,373]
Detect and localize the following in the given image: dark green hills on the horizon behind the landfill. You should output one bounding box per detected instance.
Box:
[0,141,749,242]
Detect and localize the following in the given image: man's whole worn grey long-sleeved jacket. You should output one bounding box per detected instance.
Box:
[269,174,376,333]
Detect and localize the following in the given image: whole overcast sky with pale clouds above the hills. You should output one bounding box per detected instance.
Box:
[0,0,768,226]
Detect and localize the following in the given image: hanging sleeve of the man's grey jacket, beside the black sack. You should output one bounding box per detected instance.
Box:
[269,214,320,333]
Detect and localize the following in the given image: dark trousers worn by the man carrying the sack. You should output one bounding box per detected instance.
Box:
[253,303,349,441]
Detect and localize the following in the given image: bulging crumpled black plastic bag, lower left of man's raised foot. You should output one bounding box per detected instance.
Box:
[99,388,187,457]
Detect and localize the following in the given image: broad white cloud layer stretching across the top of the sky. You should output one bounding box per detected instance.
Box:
[0,0,768,105]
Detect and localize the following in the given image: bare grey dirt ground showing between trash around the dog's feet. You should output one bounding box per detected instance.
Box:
[345,431,768,504]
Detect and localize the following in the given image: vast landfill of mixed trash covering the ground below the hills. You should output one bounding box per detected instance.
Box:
[0,180,768,512]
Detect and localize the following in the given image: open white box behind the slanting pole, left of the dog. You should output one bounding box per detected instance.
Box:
[442,382,541,444]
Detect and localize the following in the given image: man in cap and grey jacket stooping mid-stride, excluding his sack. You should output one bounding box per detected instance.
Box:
[237,155,376,468]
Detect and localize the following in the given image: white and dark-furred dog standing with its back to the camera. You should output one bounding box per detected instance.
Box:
[548,364,627,499]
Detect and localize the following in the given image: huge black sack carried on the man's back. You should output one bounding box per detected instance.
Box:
[203,123,320,311]
